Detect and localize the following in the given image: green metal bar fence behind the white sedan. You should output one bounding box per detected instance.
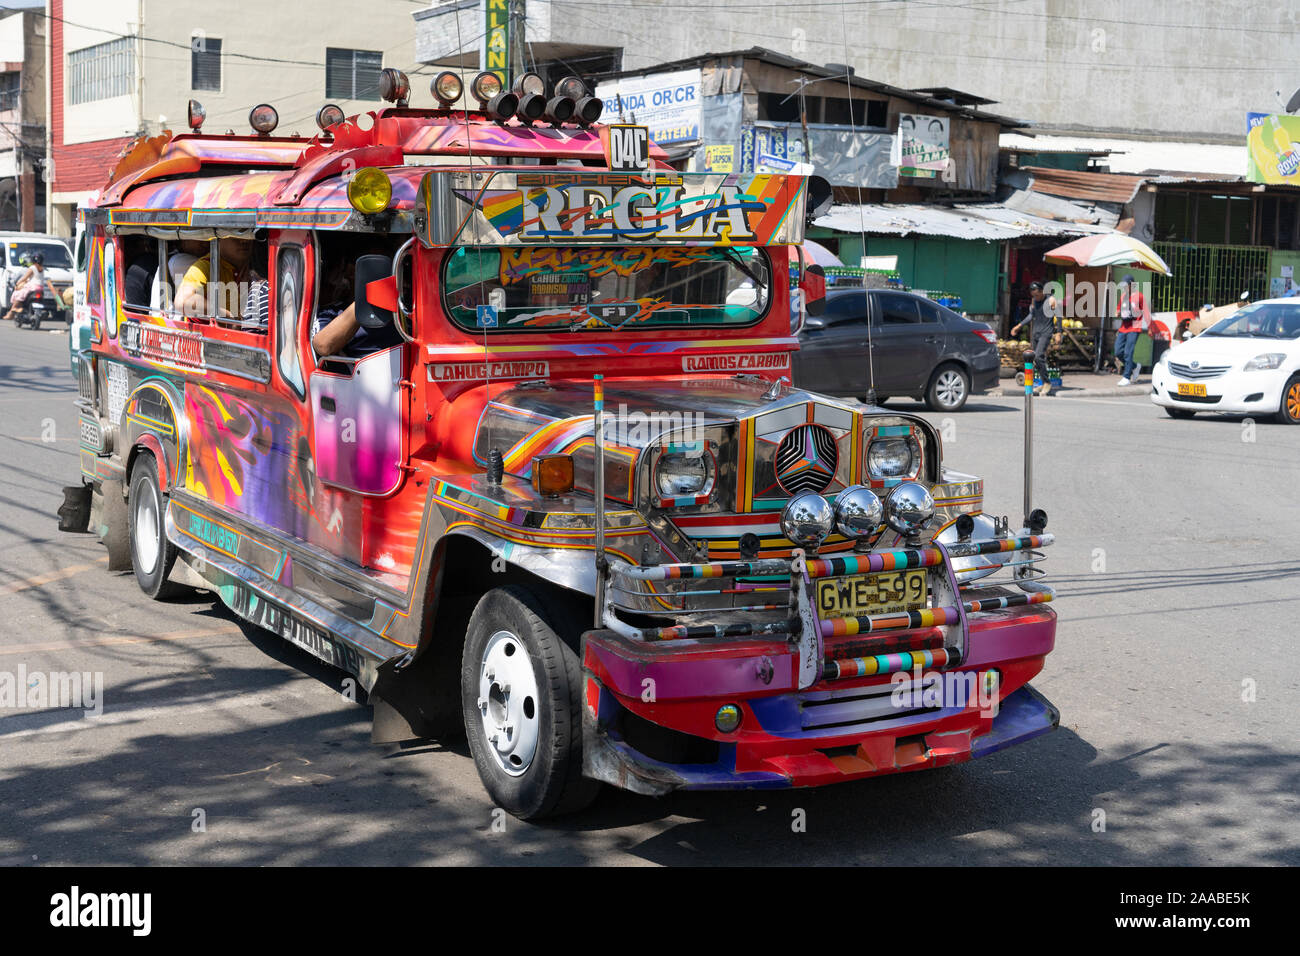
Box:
[1152,242,1270,312]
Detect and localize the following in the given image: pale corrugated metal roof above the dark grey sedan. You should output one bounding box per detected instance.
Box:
[814,203,1110,241]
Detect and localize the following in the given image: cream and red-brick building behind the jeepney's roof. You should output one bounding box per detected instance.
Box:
[48,0,419,235]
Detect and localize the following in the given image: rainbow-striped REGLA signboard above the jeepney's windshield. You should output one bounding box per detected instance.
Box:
[420,170,806,247]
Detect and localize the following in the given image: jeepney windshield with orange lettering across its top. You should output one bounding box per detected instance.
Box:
[442,246,771,332]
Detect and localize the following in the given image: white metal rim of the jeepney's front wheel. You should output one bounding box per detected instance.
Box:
[477,631,541,777]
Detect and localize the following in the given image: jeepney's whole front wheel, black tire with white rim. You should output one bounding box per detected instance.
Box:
[460,584,601,819]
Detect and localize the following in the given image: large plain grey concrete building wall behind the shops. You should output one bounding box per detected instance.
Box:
[413,0,1300,143]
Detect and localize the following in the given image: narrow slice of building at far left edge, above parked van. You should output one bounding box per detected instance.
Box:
[0,10,46,233]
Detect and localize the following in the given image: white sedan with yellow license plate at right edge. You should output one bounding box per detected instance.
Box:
[1151,299,1300,425]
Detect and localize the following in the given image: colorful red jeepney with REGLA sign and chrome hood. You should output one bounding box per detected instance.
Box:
[61,70,1057,817]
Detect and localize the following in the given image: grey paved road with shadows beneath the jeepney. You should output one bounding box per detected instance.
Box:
[0,325,1300,865]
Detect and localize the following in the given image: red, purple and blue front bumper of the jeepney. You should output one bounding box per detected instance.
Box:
[581,536,1060,795]
